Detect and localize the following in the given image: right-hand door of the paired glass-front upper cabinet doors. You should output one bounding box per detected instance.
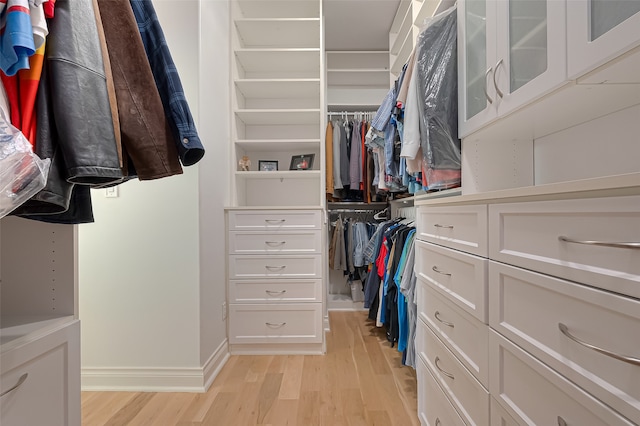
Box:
[490,0,567,116]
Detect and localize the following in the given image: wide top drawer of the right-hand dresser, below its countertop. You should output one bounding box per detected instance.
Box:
[489,196,640,298]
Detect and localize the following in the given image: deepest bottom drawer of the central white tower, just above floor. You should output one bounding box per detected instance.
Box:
[229,303,322,344]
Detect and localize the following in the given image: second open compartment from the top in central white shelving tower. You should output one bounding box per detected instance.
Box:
[235,18,320,48]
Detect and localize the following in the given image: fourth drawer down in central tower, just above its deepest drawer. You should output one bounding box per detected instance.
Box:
[229,280,322,303]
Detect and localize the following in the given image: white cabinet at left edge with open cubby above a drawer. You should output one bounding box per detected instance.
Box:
[0,217,80,426]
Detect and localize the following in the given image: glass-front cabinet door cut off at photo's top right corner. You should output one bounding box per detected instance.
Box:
[567,0,640,79]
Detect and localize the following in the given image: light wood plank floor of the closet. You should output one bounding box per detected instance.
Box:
[82,311,419,426]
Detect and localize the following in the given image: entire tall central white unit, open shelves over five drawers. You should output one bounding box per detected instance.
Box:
[226,0,326,354]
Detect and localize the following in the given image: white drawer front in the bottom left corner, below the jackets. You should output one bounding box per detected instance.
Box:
[0,320,80,426]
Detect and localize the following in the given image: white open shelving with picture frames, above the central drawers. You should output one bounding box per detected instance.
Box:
[231,0,324,207]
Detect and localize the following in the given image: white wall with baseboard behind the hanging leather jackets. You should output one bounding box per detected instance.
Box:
[79,0,229,390]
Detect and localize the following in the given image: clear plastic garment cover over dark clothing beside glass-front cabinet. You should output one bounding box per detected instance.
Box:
[414,6,461,189]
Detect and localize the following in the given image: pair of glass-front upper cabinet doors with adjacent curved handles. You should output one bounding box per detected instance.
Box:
[458,0,567,137]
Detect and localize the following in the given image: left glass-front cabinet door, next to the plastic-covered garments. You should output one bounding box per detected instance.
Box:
[458,0,498,137]
